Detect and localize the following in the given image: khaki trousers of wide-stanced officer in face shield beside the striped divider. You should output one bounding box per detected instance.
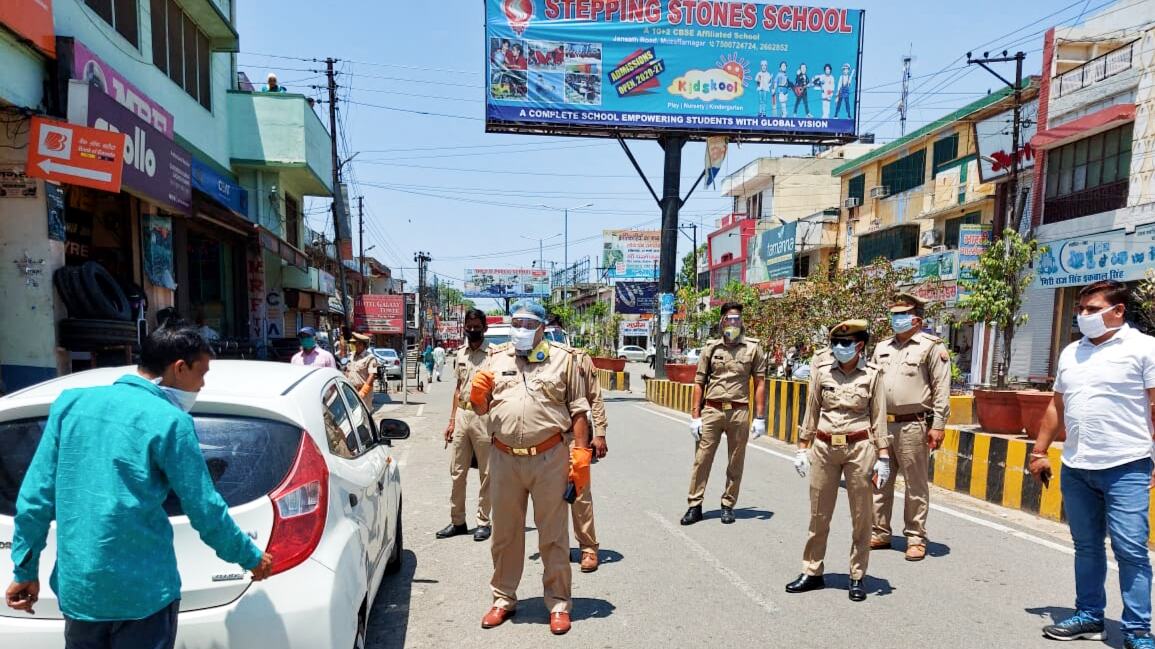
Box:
[686,405,750,507]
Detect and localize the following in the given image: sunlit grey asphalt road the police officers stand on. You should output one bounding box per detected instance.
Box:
[370,376,1136,649]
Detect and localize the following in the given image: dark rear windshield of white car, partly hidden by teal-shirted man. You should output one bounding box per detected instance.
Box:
[0,415,301,516]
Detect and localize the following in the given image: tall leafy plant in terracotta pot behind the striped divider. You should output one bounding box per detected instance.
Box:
[960,227,1042,435]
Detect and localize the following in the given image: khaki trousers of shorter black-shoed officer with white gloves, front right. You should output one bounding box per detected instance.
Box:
[802,439,878,580]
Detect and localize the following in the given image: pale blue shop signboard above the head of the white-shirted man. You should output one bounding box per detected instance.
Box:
[1031,224,1155,289]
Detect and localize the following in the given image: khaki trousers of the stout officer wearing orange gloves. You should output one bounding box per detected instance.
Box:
[490,436,573,613]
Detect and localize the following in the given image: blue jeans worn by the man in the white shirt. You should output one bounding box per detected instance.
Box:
[1061,458,1152,633]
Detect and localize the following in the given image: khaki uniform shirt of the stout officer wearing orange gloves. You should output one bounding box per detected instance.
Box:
[483,342,589,448]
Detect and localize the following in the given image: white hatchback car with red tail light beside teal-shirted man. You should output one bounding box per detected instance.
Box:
[0,360,409,649]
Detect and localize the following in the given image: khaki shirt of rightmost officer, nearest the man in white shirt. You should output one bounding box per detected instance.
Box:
[873,331,951,430]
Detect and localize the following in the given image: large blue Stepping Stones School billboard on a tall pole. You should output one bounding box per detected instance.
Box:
[485,0,864,141]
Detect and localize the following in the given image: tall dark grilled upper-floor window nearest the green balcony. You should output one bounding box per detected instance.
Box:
[149,0,213,111]
